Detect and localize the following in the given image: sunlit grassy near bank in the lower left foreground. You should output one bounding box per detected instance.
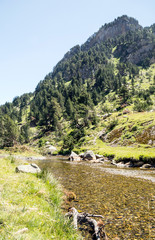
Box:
[0,158,79,240]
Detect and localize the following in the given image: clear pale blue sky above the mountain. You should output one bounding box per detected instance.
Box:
[0,0,155,105]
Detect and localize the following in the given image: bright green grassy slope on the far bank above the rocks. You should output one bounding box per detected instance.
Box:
[74,112,155,162]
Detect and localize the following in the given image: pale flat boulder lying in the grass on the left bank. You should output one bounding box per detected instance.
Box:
[15,163,41,173]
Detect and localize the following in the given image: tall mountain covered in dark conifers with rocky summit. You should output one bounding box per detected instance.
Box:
[0,15,155,158]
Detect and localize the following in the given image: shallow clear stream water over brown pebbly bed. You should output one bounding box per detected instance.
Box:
[34,158,155,240]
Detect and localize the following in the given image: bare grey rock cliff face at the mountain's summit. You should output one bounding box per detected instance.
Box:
[82,16,142,50]
